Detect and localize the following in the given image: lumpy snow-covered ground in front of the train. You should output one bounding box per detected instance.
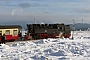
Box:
[0,31,90,60]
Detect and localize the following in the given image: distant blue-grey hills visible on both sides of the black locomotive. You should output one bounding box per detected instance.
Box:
[0,21,90,30]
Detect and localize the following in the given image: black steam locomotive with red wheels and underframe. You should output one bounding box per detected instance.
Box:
[27,24,71,39]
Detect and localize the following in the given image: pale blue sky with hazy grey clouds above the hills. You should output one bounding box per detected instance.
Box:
[0,0,90,24]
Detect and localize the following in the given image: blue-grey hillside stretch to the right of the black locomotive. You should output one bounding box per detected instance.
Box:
[70,23,90,30]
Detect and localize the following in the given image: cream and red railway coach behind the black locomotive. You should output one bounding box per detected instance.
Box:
[0,25,22,41]
